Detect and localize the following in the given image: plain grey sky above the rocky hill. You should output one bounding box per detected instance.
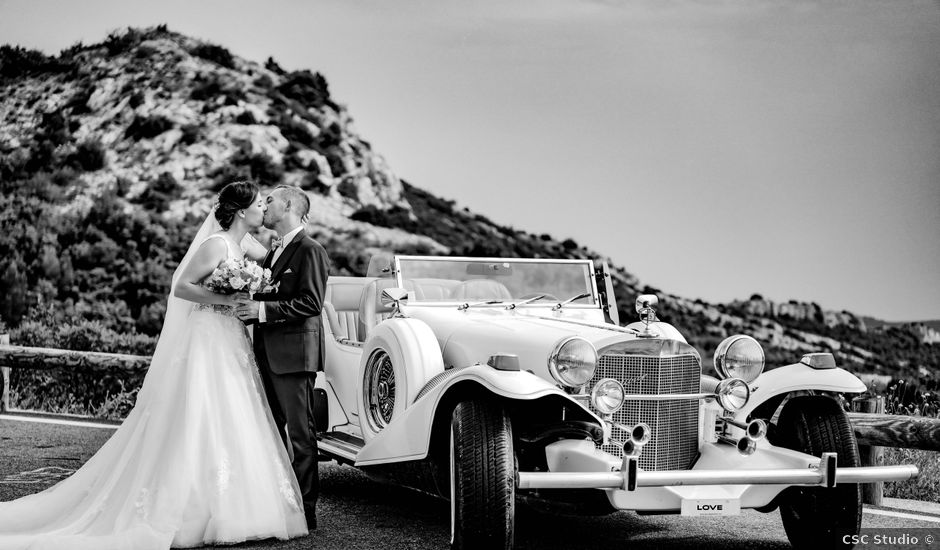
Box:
[0,0,940,321]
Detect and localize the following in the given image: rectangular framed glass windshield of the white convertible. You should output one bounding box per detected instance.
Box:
[397,257,596,306]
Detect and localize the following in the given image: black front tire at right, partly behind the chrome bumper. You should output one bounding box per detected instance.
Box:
[773,396,862,548]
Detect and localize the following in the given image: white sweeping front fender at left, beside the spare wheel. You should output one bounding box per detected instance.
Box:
[356,364,603,466]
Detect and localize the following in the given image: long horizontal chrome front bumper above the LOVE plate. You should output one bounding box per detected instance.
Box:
[516,453,919,491]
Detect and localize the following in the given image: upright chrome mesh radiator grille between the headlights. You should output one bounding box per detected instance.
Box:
[589,354,702,471]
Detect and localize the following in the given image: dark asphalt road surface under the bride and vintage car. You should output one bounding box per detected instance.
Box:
[0,419,940,550]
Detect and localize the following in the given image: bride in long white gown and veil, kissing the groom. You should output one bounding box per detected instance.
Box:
[0,182,307,550]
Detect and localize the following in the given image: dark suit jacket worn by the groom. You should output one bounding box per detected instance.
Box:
[254,231,330,374]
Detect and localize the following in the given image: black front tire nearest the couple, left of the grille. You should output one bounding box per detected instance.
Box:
[450,401,516,550]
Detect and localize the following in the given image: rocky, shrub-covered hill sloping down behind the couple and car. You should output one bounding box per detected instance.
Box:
[0,27,940,392]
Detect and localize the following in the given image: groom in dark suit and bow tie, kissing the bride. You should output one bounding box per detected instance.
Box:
[238,186,330,531]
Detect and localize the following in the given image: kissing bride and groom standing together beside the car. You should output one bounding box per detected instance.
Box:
[0,181,330,550]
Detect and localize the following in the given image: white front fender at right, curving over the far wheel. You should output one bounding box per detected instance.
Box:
[735,363,867,418]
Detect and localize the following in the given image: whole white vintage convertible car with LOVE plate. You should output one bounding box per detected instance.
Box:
[316,256,917,549]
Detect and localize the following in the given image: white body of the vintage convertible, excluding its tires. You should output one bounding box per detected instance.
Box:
[317,256,917,547]
